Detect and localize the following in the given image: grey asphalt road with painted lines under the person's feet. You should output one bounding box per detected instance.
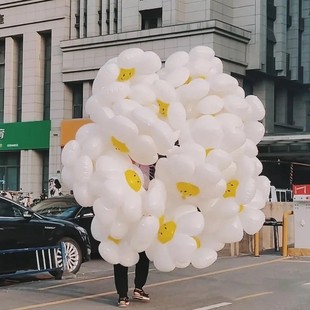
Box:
[0,254,310,310]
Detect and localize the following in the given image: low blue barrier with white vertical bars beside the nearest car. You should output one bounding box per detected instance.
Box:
[0,242,66,280]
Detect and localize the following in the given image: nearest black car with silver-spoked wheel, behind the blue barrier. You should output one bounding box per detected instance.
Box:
[0,197,91,273]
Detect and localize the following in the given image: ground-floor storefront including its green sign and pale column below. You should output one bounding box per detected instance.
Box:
[0,120,51,191]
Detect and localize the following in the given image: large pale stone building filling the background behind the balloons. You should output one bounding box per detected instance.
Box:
[0,0,310,197]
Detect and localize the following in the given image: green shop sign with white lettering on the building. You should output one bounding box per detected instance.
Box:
[0,120,51,151]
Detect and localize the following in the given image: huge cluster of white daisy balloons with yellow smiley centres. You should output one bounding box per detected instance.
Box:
[62,46,270,271]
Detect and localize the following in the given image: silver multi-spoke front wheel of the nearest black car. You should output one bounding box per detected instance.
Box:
[57,238,82,273]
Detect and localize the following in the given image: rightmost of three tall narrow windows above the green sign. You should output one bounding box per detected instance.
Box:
[42,32,52,120]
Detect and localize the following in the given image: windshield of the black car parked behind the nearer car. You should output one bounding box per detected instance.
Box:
[32,199,80,218]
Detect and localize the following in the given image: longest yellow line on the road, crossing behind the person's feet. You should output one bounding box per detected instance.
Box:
[11,257,287,310]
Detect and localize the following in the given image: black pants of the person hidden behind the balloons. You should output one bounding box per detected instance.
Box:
[114,252,150,297]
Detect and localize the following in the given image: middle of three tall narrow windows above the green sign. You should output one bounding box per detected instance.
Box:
[16,37,23,122]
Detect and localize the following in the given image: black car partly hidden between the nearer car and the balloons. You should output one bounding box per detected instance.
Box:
[32,195,99,255]
